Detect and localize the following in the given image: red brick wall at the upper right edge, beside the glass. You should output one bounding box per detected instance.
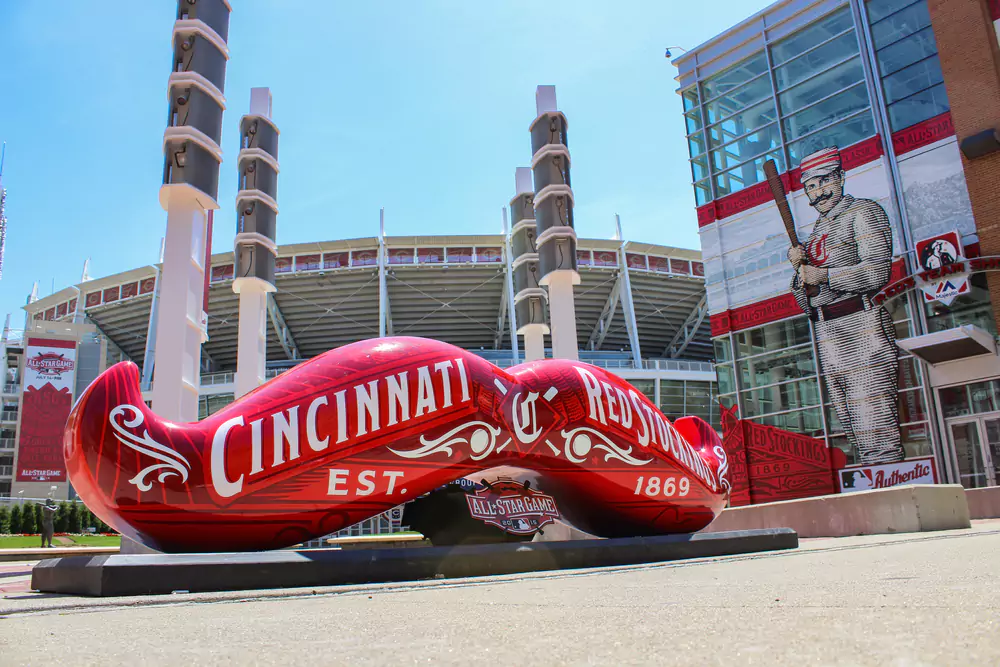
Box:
[927,0,1000,330]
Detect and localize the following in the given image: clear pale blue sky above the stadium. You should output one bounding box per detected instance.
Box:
[0,0,769,328]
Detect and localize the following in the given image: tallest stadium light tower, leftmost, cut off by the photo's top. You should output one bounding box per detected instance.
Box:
[153,0,231,421]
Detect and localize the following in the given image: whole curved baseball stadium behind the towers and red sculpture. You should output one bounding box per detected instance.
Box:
[0,234,719,512]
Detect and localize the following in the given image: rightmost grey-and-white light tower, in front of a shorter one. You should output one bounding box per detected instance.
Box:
[530,86,580,359]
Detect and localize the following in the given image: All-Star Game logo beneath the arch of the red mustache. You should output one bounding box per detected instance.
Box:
[465,479,559,535]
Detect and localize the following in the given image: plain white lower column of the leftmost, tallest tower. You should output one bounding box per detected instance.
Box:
[153,197,208,422]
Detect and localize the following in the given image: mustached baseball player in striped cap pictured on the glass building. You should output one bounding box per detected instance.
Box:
[788,147,904,465]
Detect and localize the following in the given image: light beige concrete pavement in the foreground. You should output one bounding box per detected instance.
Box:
[0,521,1000,666]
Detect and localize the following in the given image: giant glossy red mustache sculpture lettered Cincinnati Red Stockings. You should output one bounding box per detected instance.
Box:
[64,338,729,552]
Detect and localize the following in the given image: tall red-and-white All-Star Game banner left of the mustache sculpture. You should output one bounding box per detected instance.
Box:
[16,338,76,482]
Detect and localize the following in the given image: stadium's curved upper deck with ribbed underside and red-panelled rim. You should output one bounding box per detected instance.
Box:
[25,235,712,370]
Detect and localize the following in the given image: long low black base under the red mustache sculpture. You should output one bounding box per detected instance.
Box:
[31,528,799,597]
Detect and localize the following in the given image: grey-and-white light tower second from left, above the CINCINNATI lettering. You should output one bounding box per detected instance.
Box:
[233,88,280,398]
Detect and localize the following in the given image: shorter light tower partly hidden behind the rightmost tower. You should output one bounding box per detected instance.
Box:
[510,167,549,361]
